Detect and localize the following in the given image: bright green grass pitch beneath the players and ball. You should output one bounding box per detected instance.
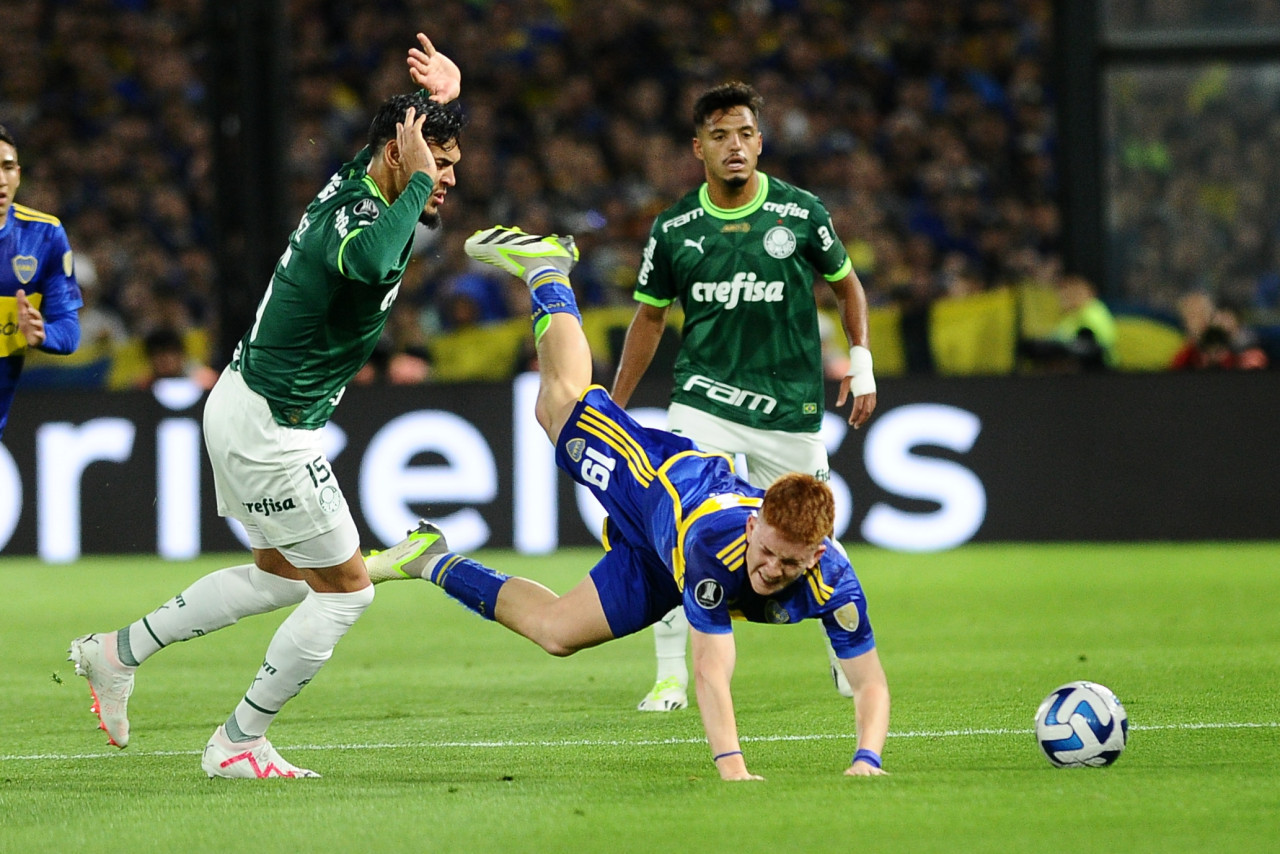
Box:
[0,543,1280,854]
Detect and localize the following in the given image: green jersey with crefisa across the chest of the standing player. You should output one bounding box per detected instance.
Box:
[635,173,852,433]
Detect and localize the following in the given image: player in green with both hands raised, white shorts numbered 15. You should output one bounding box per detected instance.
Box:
[69,35,462,778]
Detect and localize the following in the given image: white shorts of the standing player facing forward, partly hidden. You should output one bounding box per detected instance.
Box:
[667,403,831,489]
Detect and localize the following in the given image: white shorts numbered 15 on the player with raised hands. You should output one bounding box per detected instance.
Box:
[205,367,360,568]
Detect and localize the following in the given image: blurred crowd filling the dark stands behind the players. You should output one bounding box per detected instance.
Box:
[0,0,1280,387]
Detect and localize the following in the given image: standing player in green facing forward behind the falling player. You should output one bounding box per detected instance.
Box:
[612,83,876,712]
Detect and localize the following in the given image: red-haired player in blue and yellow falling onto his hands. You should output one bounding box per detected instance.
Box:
[370,227,890,780]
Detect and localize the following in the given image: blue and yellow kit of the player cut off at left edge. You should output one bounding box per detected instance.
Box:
[0,204,84,429]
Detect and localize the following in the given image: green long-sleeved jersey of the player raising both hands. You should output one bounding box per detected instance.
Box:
[232,147,431,430]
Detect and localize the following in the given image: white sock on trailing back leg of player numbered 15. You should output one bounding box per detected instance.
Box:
[116,563,310,666]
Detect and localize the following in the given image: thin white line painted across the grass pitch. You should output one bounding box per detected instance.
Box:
[0,721,1280,762]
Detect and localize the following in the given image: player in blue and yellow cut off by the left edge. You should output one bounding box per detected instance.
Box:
[0,125,84,435]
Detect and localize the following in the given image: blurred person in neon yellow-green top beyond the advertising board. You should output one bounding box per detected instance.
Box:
[1018,275,1116,373]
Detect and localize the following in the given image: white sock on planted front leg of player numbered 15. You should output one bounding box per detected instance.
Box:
[227,585,374,740]
